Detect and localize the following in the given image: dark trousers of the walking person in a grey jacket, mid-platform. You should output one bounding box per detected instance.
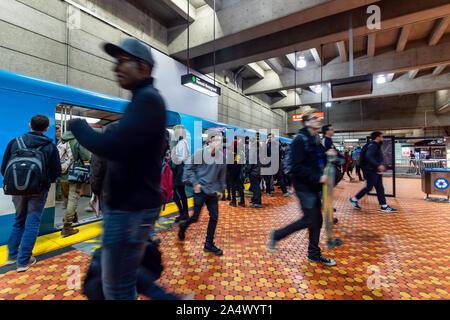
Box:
[183,191,219,244]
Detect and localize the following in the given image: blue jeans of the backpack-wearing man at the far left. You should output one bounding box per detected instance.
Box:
[8,190,48,266]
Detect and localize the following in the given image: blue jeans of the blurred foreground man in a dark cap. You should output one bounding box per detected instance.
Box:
[101,206,161,300]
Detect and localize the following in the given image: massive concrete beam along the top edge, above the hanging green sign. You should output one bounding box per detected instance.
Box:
[168,0,380,58]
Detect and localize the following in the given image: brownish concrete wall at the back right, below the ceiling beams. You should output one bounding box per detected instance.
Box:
[288,93,450,133]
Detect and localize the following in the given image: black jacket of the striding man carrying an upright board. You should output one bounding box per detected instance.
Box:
[291,128,325,192]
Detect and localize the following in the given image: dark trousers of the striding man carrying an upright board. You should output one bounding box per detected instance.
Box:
[274,191,323,259]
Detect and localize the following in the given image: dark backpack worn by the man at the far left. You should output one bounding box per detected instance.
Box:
[3,137,48,196]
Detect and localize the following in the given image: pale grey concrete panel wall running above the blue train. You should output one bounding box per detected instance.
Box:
[0,0,286,133]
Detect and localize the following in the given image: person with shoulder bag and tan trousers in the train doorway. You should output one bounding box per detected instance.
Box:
[60,122,90,238]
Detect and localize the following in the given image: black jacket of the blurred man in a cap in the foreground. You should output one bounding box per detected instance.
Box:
[71,78,166,211]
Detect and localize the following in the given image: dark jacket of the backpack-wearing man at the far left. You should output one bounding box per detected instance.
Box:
[1,131,61,189]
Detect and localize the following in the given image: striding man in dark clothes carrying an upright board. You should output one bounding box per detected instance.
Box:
[268,108,336,266]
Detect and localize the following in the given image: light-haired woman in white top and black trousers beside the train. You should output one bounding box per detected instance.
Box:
[172,125,191,222]
